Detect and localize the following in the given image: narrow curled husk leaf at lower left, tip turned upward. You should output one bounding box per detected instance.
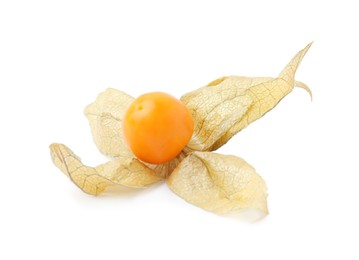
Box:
[50,144,162,195]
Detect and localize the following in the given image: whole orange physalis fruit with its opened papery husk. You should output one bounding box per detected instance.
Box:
[50,44,311,218]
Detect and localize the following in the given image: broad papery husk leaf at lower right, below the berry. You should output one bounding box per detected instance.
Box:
[167,152,268,214]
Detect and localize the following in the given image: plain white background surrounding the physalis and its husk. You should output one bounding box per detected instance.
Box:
[0,0,359,259]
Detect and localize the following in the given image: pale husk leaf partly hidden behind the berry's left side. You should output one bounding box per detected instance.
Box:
[84,88,134,158]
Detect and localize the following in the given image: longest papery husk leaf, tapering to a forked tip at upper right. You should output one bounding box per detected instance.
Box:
[181,44,311,151]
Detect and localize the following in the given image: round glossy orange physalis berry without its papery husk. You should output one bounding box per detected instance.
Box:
[123,92,194,164]
